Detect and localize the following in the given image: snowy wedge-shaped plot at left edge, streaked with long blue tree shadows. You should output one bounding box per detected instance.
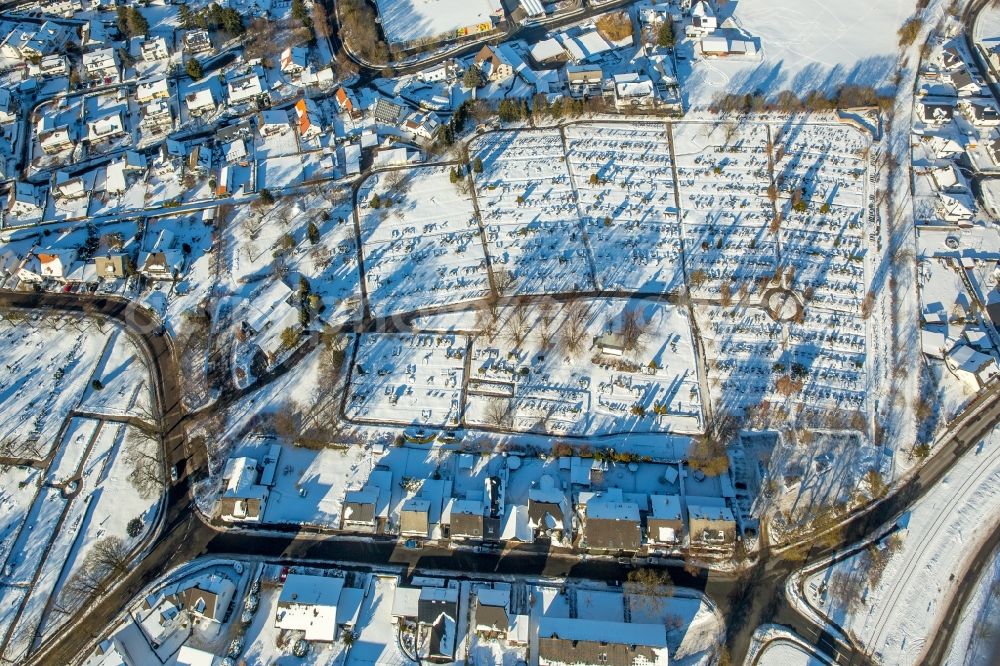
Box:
[0,315,111,460]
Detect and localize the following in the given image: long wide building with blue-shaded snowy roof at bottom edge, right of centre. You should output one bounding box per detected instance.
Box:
[538,616,670,666]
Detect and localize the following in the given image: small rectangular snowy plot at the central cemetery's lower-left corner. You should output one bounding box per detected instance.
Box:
[344,334,466,426]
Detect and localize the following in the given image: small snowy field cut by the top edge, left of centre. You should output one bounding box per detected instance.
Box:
[375,0,500,44]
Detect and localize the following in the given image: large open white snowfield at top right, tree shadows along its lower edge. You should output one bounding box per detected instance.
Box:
[679,0,914,107]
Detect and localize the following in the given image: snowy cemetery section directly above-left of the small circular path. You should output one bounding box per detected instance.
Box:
[672,121,778,296]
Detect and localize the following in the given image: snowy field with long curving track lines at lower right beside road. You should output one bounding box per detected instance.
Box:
[806,422,1000,666]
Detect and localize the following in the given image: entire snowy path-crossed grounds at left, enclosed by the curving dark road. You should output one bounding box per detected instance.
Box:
[0,315,159,660]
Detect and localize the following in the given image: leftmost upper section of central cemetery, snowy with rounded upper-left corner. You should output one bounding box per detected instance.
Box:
[358,167,489,314]
